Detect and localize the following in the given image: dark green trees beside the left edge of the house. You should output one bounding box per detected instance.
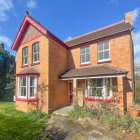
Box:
[0,44,15,98]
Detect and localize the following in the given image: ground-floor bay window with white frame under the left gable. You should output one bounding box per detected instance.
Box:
[18,76,37,98]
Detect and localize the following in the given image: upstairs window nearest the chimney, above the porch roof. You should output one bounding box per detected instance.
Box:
[98,41,110,62]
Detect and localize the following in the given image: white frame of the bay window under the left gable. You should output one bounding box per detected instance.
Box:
[17,75,38,99]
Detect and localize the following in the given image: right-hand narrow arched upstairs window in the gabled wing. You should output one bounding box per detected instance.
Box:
[33,43,39,63]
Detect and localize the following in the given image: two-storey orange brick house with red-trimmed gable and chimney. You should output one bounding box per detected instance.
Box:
[12,12,135,112]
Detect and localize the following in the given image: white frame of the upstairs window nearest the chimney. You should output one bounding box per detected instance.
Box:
[98,41,111,62]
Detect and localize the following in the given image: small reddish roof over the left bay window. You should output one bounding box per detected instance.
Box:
[16,67,40,76]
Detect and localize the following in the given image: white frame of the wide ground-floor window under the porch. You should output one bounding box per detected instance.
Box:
[87,78,112,99]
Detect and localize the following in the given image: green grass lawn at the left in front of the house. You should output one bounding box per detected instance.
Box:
[0,102,48,140]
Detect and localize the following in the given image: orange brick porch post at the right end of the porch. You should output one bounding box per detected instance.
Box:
[117,76,126,115]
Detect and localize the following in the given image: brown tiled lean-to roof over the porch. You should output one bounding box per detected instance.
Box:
[60,64,127,79]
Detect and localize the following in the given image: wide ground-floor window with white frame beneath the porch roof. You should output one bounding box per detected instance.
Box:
[87,78,112,99]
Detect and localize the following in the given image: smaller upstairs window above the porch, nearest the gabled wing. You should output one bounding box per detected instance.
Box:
[80,47,90,64]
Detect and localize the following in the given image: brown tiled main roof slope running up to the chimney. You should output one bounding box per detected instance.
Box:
[65,21,132,47]
